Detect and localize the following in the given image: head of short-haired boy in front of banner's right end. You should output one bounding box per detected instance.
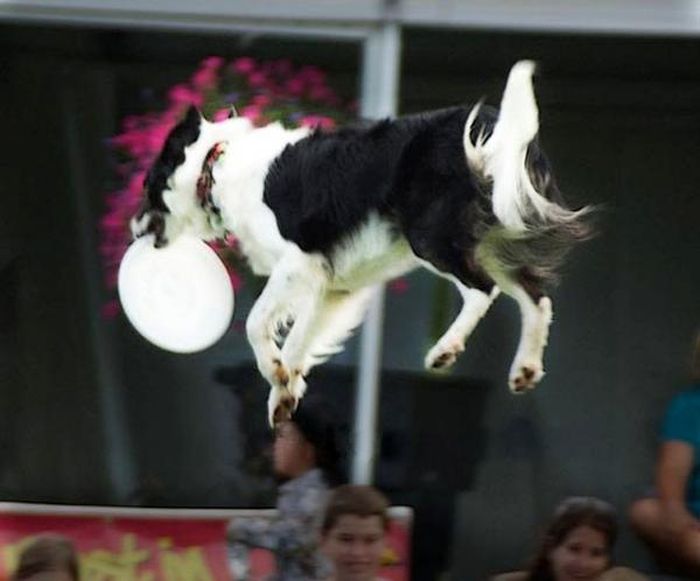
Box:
[321,484,389,581]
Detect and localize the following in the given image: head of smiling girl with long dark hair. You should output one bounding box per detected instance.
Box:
[528,497,617,581]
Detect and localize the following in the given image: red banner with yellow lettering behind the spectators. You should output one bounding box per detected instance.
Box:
[0,504,411,581]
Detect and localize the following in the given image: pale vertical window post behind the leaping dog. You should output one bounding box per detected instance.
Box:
[351,22,401,484]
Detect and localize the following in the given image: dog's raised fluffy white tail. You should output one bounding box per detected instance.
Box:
[464,61,578,230]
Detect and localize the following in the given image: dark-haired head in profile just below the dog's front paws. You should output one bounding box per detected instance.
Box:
[273,401,340,484]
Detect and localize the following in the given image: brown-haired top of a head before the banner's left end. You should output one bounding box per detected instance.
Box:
[12,534,80,581]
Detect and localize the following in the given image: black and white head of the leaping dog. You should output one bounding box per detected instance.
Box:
[131,107,252,247]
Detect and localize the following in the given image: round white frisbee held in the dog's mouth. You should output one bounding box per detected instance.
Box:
[118,235,233,353]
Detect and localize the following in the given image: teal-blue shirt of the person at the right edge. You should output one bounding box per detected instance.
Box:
[661,385,700,517]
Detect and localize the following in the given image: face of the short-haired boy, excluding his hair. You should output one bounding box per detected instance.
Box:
[323,514,384,581]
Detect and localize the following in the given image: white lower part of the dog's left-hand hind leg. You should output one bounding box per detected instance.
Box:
[425,277,499,369]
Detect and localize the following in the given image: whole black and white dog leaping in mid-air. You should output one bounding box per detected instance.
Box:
[132,61,589,423]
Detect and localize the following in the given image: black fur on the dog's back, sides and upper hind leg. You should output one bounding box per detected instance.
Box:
[264,107,493,285]
